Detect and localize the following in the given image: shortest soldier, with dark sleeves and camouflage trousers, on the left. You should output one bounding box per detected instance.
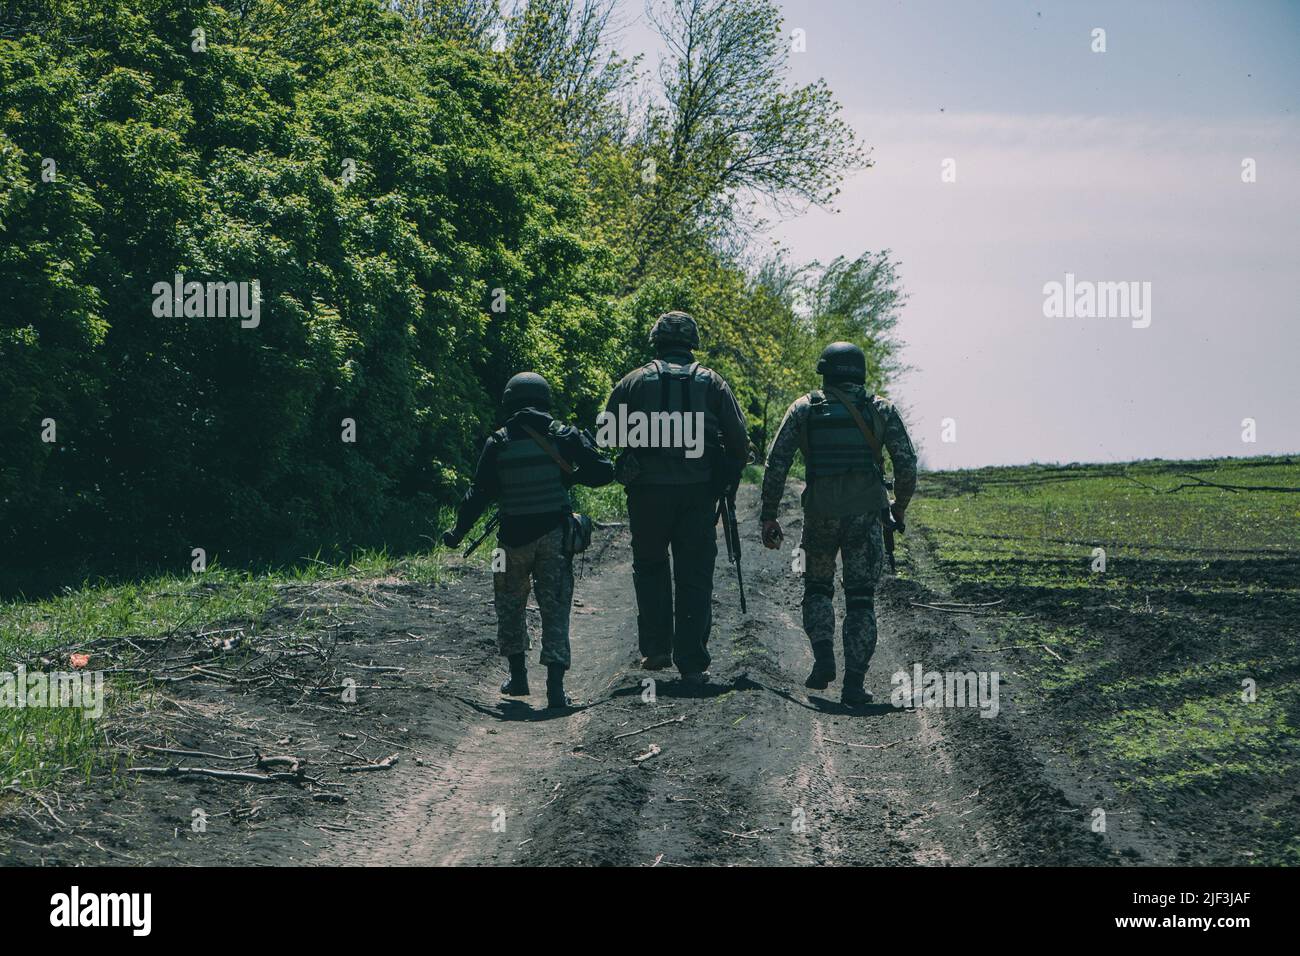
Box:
[442,372,614,708]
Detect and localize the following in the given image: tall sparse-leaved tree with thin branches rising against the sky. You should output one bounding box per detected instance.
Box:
[629,0,866,281]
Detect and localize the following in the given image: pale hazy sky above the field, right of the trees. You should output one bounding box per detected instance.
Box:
[620,0,1300,468]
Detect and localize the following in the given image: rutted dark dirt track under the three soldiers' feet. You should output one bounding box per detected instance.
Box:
[0,488,1118,865]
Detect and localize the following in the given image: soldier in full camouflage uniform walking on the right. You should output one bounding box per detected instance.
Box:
[761,342,917,706]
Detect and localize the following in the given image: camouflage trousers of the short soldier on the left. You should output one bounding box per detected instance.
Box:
[493,527,573,667]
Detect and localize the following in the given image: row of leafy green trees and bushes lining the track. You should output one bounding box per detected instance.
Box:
[0,0,901,591]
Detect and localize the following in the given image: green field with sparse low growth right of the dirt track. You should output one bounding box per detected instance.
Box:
[910,458,1300,862]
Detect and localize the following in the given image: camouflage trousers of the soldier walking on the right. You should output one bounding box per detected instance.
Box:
[800,515,885,674]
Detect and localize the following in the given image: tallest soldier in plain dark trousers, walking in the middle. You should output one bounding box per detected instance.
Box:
[606,312,749,687]
